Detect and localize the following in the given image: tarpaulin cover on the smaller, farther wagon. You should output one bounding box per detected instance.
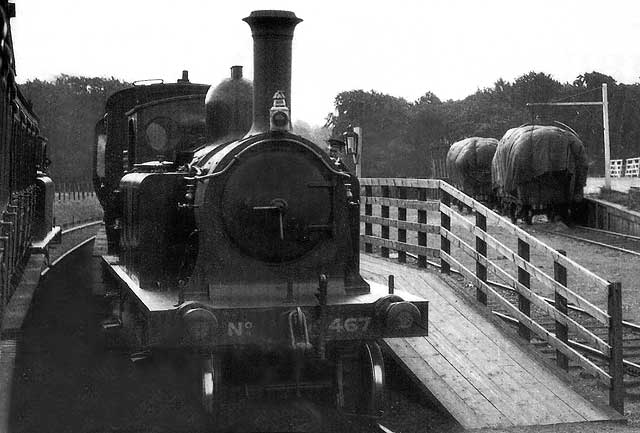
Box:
[447,137,498,194]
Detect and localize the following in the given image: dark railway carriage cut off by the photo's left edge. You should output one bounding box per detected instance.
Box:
[0,0,60,321]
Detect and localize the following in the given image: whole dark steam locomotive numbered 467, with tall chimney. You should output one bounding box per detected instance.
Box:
[94,11,428,414]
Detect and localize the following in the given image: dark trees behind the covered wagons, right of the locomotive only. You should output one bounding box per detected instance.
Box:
[325,72,640,177]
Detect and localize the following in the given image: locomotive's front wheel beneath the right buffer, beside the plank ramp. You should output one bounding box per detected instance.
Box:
[336,342,385,416]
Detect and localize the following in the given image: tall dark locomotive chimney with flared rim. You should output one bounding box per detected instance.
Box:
[243,10,302,135]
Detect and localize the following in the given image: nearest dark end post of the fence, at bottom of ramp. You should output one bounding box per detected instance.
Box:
[608,282,625,415]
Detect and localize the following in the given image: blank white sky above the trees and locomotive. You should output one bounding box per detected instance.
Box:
[12,0,640,125]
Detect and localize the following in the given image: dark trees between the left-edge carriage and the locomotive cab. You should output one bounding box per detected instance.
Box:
[20,74,128,182]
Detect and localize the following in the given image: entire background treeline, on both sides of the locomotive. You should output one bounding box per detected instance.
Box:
[21,72,640,182]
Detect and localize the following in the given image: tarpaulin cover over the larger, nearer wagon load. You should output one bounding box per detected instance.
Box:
[491,125,588,195]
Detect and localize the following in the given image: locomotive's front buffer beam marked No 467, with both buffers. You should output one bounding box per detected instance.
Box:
[180,292,428,349]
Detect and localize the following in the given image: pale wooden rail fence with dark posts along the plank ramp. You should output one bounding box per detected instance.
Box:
[360,178,624,413]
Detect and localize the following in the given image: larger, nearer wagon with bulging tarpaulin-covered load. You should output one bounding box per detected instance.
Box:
[491,125,588,224]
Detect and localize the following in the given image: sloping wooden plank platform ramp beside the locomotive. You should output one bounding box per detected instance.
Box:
[361,255,615,428]
